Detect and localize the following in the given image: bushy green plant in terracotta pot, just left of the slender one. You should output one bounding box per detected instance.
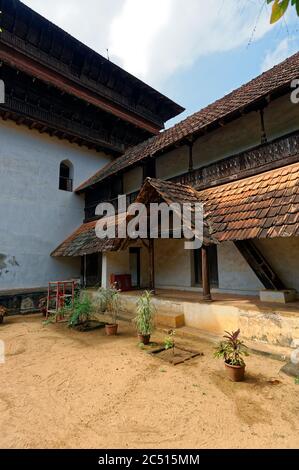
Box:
[96,284,120,336]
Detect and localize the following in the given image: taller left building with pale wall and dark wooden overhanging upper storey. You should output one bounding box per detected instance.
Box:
[0,0,183,307]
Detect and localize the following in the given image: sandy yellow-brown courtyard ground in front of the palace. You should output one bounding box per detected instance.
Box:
[0,317,299,448]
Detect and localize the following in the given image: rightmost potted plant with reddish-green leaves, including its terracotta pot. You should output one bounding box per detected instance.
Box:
[215,330,248,382]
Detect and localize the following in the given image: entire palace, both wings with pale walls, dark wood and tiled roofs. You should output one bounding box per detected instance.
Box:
[0,0,299,356]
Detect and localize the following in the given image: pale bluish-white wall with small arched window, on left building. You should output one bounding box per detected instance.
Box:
[0,120,110,290]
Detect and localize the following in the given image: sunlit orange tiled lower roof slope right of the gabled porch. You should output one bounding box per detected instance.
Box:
[198,163,299,242]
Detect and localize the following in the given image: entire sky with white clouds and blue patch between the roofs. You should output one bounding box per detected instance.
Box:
[23,0,299,127]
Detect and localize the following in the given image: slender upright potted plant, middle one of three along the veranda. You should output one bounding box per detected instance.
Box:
[133,291,155,344]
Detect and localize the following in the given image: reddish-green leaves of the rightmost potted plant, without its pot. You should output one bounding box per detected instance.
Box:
[214,330,249,366]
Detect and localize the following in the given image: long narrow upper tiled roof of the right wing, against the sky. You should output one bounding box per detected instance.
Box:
[77,52,299,191]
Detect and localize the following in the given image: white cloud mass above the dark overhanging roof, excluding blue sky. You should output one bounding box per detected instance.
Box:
[23,0,278,87]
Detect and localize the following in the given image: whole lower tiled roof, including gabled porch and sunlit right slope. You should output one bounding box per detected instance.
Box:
[52,163,299,256]
